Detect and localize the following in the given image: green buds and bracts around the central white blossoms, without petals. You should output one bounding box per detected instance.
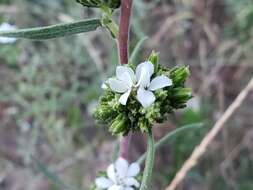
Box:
[95,53,192,135]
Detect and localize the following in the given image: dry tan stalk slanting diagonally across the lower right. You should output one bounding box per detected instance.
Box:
[166,78,253,190]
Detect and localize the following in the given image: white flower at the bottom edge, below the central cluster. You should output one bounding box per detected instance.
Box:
[95,158,140,190]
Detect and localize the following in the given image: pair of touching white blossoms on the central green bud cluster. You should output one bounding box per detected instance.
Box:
[106,61,172,108]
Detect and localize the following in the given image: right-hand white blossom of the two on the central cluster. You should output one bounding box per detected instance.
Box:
[136,62,172,108]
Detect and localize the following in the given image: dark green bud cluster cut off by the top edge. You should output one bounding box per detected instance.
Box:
[76,0,121,9]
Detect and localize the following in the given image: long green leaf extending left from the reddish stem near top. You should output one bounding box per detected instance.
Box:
[0,19,101,40]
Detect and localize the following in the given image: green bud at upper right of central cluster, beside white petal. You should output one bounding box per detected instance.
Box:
[170,66,190,86]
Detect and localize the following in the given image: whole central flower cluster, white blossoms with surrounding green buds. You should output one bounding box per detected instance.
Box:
[95,53,192,135]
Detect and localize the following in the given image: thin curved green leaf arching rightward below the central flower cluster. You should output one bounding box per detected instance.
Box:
[137,123,203,164]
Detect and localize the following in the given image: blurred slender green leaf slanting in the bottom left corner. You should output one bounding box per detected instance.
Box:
[32,157,77,190]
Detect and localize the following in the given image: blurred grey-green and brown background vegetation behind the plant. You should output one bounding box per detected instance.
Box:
[0,0,253,190]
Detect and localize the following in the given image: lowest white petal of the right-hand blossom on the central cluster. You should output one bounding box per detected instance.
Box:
[137,88,155,108]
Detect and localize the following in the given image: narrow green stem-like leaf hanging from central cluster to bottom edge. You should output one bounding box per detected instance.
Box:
[140,130,155,190]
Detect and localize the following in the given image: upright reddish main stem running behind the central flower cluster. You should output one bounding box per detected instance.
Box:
[118,0,133,160]
